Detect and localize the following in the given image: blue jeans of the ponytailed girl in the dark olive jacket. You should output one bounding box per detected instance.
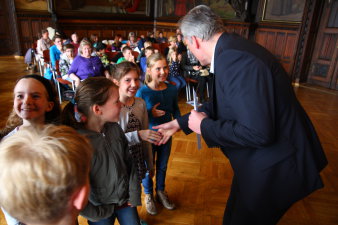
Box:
[88,207,140,225]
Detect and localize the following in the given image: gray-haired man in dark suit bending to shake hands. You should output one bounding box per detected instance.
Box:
[154,6,327,225]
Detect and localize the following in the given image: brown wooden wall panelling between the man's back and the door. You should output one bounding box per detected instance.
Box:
[255,28,298,76]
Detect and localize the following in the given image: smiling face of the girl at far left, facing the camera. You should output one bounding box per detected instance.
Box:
[14,78,54,124]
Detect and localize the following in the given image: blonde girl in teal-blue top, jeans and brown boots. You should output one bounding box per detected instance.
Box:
[136,53,180,215]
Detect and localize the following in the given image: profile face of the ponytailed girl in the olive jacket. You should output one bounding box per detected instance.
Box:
[100,87,121,122]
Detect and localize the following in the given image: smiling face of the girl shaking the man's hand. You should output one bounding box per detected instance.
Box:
[119,70,140,97]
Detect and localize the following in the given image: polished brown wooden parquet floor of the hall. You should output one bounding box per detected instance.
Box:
[0,57,338,225]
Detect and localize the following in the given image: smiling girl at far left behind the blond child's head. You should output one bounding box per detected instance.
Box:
[1,74,61,225]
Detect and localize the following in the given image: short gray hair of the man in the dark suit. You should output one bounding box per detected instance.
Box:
[179,5,224,41]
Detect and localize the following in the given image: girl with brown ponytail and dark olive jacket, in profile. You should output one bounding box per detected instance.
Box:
[62,77,141,225]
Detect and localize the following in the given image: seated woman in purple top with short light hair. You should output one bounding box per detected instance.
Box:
[68,41,106,86]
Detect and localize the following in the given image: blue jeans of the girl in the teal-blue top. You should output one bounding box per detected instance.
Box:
[142,138,172,194]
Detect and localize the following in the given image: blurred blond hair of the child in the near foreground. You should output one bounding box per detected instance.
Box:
[0,125,92,223]
